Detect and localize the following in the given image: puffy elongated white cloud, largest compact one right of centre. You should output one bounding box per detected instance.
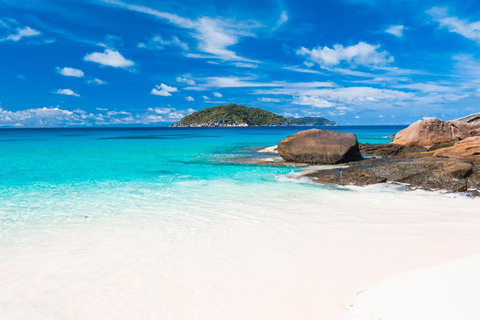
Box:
[296,42,393,67]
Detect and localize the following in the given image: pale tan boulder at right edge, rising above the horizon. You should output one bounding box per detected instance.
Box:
[392,113,480,146]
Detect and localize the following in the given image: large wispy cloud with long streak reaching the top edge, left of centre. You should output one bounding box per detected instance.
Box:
[101,0,261,62]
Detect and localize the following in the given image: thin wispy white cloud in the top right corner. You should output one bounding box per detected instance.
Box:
[427,7,480,42]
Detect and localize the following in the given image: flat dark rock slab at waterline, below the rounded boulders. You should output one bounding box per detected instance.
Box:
[306,159,473,192]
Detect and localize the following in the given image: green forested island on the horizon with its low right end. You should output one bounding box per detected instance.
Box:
[171,103,337,127]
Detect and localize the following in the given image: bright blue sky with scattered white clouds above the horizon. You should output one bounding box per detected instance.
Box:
[0,0,480,127]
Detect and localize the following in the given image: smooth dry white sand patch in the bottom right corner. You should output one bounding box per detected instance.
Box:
[344,255,480,320]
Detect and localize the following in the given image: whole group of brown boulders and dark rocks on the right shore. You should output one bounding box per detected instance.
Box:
[260,113,480,196]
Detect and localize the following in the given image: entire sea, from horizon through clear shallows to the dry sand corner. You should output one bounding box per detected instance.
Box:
[0,126,480,319]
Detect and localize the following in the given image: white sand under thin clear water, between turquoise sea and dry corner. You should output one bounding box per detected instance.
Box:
[0,181,480,320]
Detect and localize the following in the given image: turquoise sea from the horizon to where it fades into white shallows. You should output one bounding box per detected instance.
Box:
[0,126,403,232]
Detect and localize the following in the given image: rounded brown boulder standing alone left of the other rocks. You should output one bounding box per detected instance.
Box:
[278,129,363,164]
